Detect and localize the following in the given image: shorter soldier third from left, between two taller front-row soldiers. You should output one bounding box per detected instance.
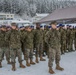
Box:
[24,25,35,67]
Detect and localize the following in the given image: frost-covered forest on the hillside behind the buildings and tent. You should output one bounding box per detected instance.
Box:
[0,0,76,17]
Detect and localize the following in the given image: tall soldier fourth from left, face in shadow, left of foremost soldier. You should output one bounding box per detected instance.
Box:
[34,24,45,63]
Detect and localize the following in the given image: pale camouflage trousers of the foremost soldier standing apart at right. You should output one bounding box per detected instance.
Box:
[48,47,61,68]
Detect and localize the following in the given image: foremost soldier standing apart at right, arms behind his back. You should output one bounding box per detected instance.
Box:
[45,22,64,74]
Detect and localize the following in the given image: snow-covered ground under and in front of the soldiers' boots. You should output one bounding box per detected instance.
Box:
[0,52,76,75]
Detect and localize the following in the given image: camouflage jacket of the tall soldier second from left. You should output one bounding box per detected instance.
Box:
[9,29,21,49]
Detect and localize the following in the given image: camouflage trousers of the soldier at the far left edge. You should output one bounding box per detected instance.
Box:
[0,48,10,62]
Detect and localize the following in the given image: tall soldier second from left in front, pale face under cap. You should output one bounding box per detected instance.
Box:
[9,23,25,71]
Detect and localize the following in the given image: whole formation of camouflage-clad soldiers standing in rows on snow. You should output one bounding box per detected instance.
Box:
[0,22,76,74]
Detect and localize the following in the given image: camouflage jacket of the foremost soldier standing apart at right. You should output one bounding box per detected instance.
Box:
[45,29,61,48]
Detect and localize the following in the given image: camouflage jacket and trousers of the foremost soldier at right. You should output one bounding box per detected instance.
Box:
[45,29,61,68]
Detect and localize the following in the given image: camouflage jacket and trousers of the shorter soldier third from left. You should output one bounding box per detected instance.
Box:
[24,31,33,60]
